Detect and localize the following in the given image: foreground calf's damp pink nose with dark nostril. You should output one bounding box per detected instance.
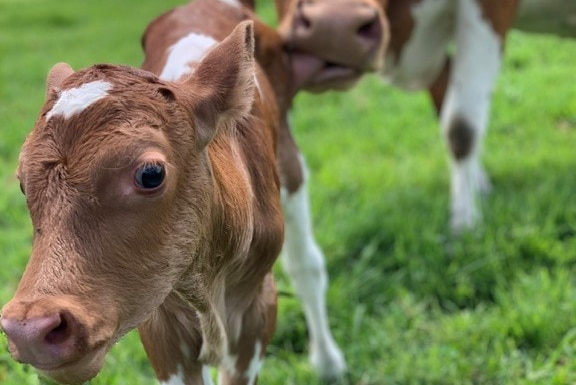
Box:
[0,312,79,369]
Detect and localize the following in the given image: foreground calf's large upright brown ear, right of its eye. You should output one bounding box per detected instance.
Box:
[185,21,255,145]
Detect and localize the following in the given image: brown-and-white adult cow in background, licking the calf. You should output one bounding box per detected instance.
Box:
[276,0,520,232]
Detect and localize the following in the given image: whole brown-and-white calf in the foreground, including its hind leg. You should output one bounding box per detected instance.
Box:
[2,0,345,384]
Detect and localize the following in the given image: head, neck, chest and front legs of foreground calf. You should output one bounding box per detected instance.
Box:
[1,22,283,384]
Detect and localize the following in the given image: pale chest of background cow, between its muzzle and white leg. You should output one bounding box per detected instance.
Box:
[382,0,456,90]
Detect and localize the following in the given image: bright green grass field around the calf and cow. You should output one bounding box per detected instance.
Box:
[0,0,576,385]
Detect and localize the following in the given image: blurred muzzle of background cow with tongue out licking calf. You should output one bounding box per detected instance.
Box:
[276,0,389,92]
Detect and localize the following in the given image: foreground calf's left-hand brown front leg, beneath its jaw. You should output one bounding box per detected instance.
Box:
[138,294,212,385]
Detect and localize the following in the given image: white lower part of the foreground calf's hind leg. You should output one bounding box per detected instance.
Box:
[282,159,346,378]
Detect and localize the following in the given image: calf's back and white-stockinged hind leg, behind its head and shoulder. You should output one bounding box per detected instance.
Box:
[142,0,346,379]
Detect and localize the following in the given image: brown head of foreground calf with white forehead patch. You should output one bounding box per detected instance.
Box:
[1,23,254,384]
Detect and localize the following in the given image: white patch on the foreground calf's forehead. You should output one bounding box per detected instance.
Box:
[46,80,112,121]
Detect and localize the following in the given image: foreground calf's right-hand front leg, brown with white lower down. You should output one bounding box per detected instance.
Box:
[218,273,278,385]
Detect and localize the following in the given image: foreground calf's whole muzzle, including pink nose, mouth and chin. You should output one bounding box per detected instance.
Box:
[0,297,110,384]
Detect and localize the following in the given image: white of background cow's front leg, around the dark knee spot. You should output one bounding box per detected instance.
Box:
[441,0,502,231]
